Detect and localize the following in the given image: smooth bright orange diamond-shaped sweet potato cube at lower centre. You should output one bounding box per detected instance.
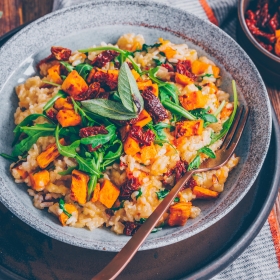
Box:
[99,179,120,208]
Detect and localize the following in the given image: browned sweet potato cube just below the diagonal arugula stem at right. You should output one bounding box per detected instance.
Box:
[175,120,203,137]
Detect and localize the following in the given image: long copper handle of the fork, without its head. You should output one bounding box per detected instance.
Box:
[92,170,194,280]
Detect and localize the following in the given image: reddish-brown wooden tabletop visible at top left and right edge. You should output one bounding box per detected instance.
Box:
[0,0,280,278]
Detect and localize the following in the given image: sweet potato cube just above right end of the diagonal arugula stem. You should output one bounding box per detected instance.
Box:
[179,91,208,111]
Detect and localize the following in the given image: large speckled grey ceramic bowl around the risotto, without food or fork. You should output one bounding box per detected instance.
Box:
[0,1,272,251]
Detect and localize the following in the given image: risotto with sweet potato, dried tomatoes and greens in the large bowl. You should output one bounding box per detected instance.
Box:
[2,34,239,235]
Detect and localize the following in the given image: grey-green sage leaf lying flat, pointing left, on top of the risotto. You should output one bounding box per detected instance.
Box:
[81,98,137,120]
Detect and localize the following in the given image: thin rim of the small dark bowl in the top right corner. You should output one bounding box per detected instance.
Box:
[238,0,280,63]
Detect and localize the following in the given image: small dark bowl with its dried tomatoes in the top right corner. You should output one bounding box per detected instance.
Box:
[237,0,280,85]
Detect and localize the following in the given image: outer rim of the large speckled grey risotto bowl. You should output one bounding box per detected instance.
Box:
[0,0,272,252]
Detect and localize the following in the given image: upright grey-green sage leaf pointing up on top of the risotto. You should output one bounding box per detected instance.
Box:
[118,62,144,113]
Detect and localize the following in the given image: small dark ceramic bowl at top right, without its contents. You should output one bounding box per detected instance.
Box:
[238,0,280,85]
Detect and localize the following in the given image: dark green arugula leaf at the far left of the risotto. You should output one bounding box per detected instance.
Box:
[12,123,55,157]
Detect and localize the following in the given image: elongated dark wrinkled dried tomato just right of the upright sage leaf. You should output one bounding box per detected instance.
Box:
[142,88,168,123]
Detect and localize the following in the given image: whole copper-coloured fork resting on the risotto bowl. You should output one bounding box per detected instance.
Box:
[92,107,249,280]
